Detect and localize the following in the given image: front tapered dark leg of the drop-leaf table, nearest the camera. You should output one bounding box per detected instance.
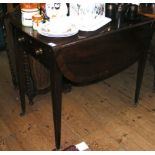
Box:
[50,64,62,150]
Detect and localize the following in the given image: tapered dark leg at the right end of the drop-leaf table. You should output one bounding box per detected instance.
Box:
[135,53,147,105]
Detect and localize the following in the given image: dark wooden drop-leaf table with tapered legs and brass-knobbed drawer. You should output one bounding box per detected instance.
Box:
[6,10,154,149]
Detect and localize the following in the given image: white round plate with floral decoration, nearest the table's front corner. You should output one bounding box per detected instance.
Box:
[37,20,79,37]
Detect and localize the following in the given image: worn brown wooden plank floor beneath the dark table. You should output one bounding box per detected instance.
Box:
[0,52,155,150]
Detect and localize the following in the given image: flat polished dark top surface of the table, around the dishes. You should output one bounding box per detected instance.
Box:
[10,9,153,49]
